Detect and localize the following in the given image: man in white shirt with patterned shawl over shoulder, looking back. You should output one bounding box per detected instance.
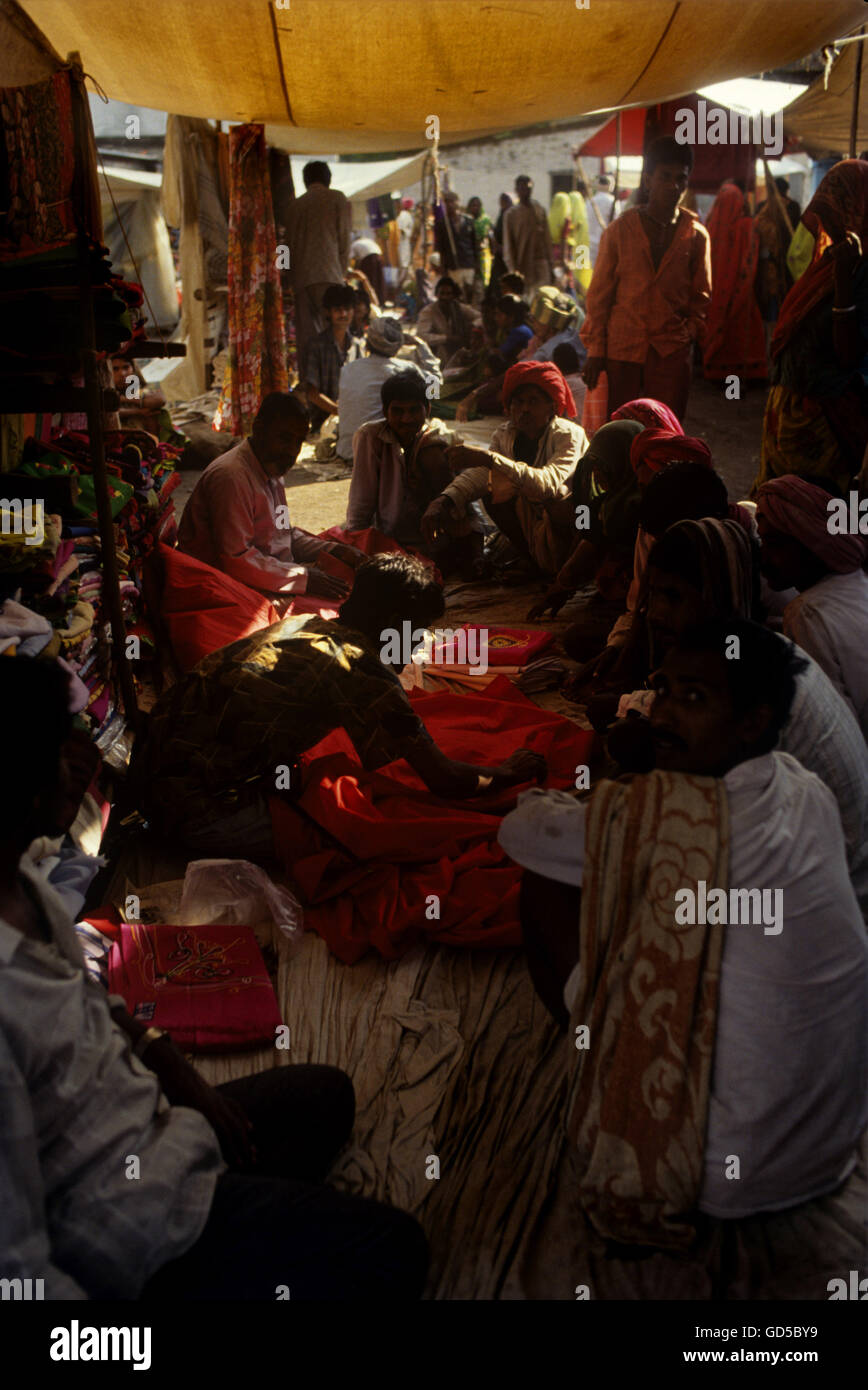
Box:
[499,619,868,1248]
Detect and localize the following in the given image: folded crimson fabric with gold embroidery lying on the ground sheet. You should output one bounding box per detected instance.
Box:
[109,922,282,1052]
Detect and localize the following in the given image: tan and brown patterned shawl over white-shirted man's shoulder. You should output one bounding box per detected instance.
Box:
[566,770,729,1251]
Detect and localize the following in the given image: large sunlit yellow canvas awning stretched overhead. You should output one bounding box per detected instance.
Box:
[24,0,865,153]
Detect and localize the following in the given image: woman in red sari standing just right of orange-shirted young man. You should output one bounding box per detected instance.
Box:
[702,182,766,381]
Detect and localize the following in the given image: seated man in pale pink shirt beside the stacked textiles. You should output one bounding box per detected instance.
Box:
[178,391,364,599]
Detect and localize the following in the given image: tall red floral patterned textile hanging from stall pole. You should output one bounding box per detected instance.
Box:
[220,124,289,435]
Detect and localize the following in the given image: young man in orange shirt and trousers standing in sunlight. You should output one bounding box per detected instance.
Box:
[581,136,711,421]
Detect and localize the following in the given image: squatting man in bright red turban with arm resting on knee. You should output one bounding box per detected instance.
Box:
[421,361,588,575]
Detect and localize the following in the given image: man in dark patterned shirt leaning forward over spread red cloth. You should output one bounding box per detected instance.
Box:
[132,553,547,859]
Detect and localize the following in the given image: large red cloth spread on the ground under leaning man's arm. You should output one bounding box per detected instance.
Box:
[271,677,593,963]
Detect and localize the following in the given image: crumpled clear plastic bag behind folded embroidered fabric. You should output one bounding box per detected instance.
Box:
[177,859,305,948]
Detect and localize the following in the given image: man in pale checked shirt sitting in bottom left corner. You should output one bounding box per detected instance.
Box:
[0,657,427,1302]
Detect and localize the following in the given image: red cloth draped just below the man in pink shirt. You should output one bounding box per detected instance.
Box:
[160,545,278,671]
